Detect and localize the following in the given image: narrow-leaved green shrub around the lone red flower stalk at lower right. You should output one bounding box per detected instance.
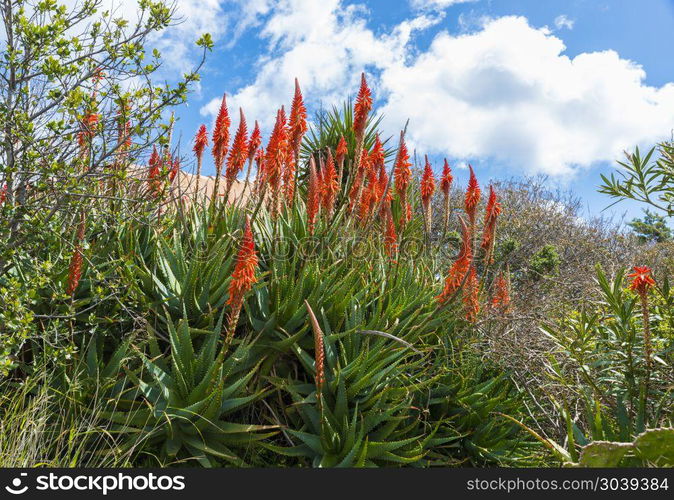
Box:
[542,269,674,460]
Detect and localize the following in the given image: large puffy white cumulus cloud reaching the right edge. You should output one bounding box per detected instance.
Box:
[381,17,674,175]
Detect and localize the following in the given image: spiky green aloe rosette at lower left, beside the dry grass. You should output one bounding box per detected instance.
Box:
[96,315,272,466]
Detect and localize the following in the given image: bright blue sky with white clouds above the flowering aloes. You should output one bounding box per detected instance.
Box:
[147,0,674,223]
